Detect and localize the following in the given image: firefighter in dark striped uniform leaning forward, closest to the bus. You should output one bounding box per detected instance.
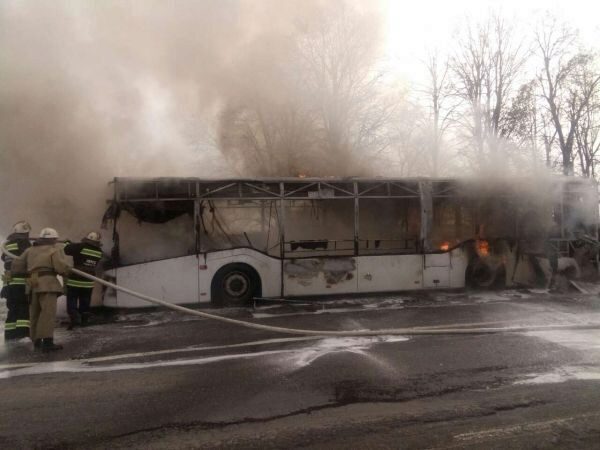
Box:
[65,231,104,329]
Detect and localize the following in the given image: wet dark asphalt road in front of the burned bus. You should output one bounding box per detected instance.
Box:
[0,291,600,449]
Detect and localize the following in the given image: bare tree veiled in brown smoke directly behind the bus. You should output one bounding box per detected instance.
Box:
[219,5,396,176]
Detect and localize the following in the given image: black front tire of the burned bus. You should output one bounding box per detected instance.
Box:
[211,263,260,307]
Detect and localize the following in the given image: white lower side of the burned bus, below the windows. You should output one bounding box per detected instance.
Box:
[104,248,468,308]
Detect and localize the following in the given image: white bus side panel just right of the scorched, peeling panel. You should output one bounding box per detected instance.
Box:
[358,255,423,292]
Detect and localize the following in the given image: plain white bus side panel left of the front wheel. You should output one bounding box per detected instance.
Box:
[104,255,198,308]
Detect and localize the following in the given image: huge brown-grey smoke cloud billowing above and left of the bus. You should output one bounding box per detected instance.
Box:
[0,0,556,252]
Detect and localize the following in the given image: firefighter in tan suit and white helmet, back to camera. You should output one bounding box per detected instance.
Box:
[12,228,71,352]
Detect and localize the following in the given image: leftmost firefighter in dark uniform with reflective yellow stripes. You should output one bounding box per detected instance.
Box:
[2,220,31,341]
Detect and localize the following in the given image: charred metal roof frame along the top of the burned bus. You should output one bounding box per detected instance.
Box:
[112,176,597,203]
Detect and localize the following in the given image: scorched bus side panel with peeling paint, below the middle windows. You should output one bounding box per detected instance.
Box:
[283,257,357,297]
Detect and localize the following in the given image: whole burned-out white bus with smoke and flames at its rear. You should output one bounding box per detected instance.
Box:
[104,177,598,307]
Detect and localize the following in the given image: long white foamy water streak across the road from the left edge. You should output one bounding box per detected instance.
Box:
[0,336,408,379]
